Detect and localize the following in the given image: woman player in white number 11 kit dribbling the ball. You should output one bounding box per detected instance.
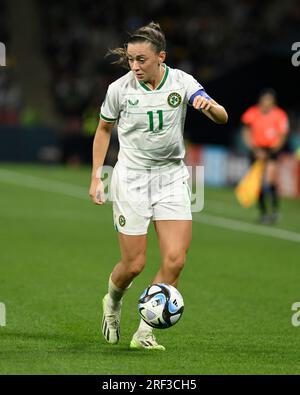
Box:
[89,22,228,350]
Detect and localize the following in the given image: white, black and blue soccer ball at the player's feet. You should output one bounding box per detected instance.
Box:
[138,284,184,329]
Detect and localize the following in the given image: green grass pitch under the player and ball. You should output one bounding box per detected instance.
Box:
[0,165,300,375]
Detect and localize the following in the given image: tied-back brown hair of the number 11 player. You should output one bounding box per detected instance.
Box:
[106,22,166,69]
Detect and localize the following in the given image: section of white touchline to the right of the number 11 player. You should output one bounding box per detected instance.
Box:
[193,214,300,243]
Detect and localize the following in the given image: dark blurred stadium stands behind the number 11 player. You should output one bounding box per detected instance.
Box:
[0,0,300,164]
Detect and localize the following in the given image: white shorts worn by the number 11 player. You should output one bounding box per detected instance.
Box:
[111,163,192,235]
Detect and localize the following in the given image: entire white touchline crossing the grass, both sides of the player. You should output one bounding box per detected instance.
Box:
[0,169,300,243]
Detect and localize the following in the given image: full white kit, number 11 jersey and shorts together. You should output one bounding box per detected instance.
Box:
[100,65,207,235]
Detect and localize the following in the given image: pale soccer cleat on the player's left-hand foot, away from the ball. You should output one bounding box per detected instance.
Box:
[101,294,121,344]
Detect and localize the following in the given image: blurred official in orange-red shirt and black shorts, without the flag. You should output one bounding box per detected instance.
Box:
[241,89,289,223]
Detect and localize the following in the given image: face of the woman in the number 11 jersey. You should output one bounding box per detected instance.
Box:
[127,42,166,82]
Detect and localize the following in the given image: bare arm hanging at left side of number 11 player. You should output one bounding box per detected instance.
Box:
[89,119,115,205]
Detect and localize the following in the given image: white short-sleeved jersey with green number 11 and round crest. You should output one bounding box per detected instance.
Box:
[100,65,203,169]
